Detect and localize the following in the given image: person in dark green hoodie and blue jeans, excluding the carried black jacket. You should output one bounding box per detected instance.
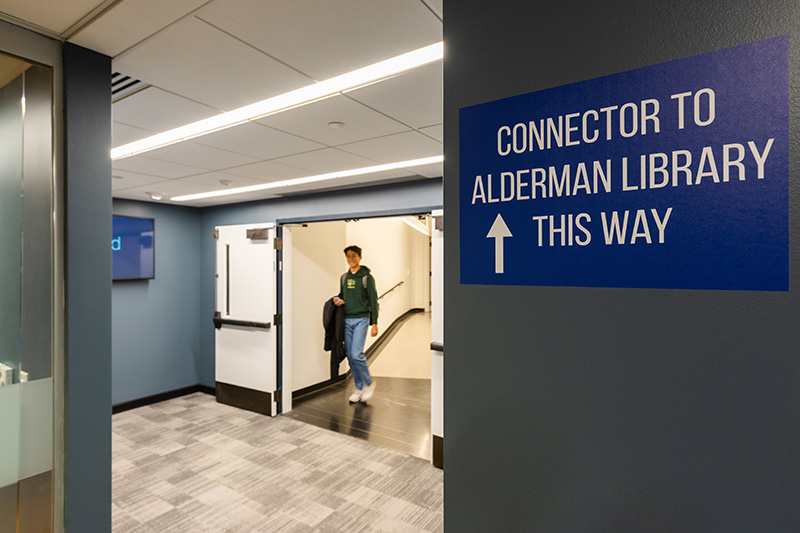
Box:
[334,245,378,403]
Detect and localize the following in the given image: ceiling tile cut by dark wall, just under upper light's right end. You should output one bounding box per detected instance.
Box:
[347,61,442,128]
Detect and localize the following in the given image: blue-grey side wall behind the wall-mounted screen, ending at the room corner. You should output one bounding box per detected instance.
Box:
[112,200,202,405]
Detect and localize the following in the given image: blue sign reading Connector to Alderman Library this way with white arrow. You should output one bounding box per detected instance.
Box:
[459,36,789,291]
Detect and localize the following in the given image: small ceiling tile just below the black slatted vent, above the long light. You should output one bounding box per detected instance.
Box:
[111,87,220,138]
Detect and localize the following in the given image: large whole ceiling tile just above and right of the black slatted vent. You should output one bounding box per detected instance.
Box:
[114,17,311,111]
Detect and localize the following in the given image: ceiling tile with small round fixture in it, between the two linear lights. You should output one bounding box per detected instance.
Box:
[256,96,408,146]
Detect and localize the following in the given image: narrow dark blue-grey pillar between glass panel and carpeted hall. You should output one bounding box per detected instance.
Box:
[64,43,111,533]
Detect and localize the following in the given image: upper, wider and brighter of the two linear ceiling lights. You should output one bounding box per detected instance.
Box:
[111,42,443,160]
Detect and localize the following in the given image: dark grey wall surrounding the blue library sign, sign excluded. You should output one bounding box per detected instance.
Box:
[444,0,800,532]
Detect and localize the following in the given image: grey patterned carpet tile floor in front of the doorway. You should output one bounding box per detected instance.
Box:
[112,393,443,533]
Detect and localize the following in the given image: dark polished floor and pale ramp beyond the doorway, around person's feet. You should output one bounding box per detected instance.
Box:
[286,313,432,461]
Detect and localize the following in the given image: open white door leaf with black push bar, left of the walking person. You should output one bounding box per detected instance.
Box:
[214,224,282,416]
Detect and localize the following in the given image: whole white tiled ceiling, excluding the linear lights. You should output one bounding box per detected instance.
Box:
[0,0,442,207]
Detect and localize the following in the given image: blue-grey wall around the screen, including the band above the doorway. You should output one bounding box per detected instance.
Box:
[109,179,442,405]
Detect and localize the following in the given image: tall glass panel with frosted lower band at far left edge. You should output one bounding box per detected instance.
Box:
[0,53,53,533]
